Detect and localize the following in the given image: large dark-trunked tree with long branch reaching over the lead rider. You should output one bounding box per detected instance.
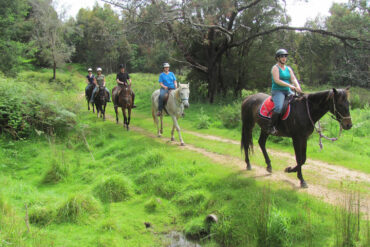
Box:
[103,0,368,102]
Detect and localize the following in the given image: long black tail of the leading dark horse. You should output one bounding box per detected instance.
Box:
[240,98,255,153]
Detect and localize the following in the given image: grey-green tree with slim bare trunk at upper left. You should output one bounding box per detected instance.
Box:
[31,0,75,80]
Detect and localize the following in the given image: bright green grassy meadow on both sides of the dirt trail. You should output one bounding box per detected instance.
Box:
[0,65,370,247]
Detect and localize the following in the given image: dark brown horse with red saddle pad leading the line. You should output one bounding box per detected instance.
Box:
[241,88,352,188]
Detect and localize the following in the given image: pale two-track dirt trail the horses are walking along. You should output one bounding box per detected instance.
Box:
[96,109,370,214]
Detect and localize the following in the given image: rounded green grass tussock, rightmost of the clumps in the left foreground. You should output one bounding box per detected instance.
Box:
[94,176,133,203]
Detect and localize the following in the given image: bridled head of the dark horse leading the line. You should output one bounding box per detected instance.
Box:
[330,87,352,130]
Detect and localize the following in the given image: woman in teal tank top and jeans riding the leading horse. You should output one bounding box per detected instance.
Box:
[268,49,302,134]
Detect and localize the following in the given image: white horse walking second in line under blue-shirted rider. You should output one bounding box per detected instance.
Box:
[152,83,190,146]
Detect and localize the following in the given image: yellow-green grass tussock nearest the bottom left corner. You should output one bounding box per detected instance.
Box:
[57,194,100,222]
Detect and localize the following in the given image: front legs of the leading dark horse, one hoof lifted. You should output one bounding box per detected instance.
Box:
[285,137,308,188]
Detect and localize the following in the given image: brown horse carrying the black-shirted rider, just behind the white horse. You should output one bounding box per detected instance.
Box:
[112,83,132,131]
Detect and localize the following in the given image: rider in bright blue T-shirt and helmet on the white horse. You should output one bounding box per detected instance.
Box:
[157,63,177,116]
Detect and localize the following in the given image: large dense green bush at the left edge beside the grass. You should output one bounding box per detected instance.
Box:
[0,76,75,138]
